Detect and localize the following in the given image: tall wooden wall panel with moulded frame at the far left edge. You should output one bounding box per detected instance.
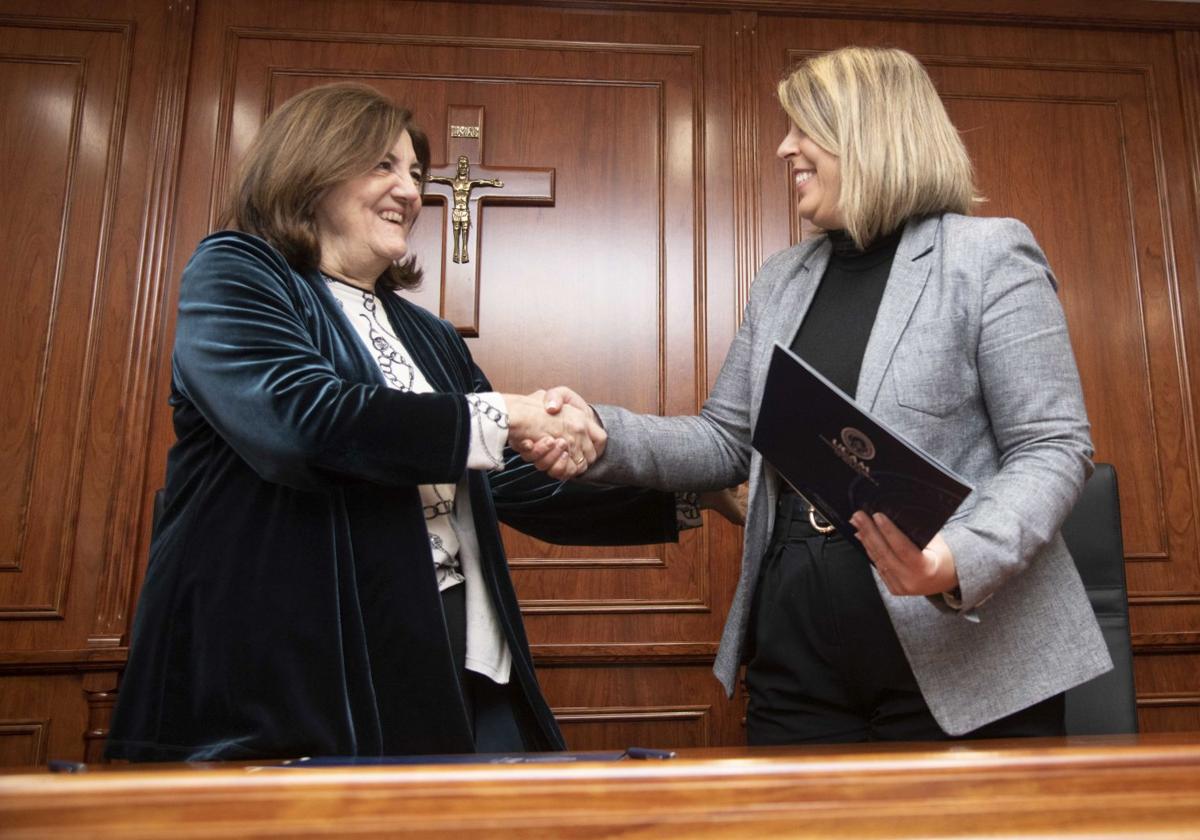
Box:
[0,16,132,635]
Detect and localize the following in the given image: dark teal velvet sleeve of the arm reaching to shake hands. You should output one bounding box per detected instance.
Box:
[173,233,469,488]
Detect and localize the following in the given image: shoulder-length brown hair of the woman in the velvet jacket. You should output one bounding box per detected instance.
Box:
[222,82,430,289]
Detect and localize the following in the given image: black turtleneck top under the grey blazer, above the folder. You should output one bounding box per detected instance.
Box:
[792,228,904,397]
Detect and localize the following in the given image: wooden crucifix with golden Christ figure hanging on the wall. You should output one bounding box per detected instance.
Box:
[425,106,554,336]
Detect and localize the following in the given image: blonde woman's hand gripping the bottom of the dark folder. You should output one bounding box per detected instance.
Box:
[850,510,959,595]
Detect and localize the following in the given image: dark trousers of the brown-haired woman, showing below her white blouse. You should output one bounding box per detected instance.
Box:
[442,583,527,752]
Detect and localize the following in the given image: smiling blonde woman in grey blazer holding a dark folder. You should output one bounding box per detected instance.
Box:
[540,47,1111,744]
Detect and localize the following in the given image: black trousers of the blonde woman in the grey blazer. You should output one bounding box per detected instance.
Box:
[746,493,1064,744]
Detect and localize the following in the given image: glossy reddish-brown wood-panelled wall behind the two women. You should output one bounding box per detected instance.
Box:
[0,0,1200,764]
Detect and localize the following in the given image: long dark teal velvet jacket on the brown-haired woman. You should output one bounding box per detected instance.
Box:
[107,232,676,761]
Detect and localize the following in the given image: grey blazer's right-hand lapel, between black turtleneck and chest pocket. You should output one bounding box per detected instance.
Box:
[854,216,941,409]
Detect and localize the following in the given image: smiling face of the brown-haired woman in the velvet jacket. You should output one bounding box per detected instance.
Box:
[316,131,421,289]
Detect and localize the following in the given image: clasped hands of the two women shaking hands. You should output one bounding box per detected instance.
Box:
[504,386,608,480]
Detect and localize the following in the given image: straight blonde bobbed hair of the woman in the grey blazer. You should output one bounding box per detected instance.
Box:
[776,47,980,247]
